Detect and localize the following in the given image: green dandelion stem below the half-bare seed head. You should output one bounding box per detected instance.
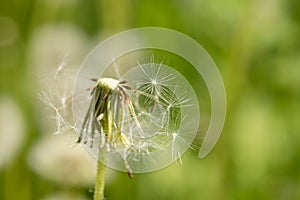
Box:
[94,156,106,200]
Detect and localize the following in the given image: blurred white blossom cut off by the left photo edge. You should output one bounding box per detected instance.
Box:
[0,96,25,169]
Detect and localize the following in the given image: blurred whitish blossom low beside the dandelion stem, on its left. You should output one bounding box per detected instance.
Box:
[28,134,96,186]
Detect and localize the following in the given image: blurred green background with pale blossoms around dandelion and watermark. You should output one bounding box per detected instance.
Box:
[0,0,300,200]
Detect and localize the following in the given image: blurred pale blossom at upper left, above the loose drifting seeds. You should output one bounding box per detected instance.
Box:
[28,24,87,80]
